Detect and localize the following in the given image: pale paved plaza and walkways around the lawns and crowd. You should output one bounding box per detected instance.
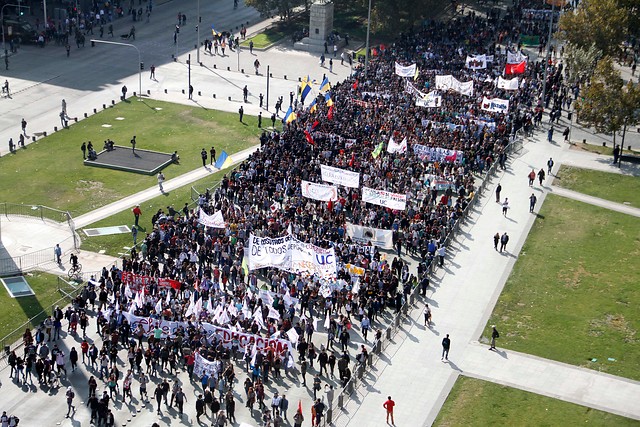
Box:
[0,1,640,427]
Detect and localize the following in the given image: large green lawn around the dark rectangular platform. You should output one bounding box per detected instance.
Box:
[0,98,259,216]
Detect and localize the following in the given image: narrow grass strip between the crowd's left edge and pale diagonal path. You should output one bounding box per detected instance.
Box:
[80,169,231,257]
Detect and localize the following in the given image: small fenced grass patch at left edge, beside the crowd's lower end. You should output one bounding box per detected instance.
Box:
[0,271,66,345]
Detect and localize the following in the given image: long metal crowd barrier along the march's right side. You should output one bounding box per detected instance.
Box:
[327,132,522,425]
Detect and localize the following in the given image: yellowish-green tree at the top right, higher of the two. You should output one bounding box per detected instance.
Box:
[558,0,629,55]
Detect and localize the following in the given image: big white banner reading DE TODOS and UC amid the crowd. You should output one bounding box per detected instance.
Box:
[247,234,337,279]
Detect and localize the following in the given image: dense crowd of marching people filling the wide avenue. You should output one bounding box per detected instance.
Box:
[3,0,576,426]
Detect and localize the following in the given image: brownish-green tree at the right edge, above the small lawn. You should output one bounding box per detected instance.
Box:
[576,57,640,149]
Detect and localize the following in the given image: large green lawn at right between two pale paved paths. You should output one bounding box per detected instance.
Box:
[482,194,640,380]
